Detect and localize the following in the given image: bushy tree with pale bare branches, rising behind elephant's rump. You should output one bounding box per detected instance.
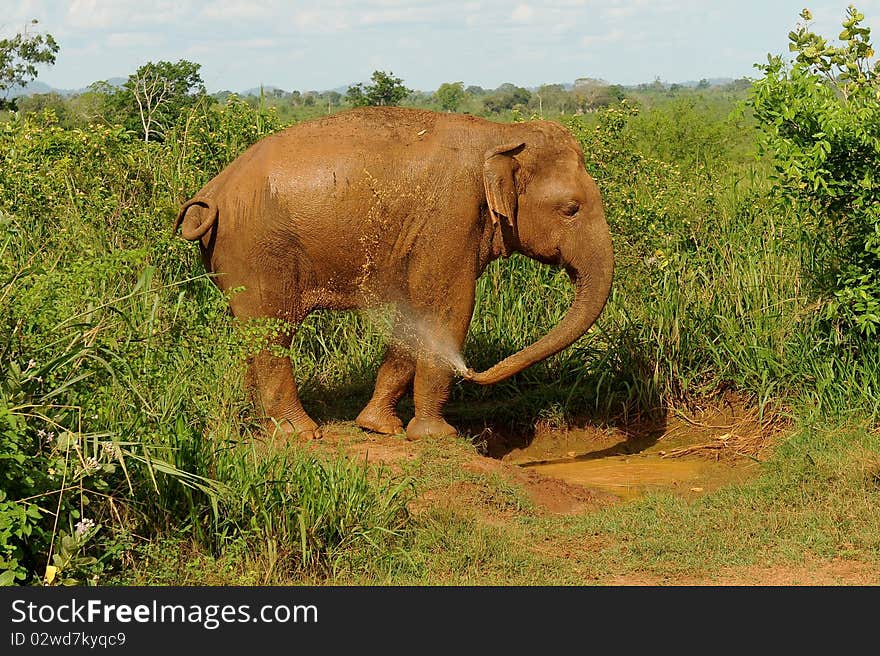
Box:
[115,59,207,141]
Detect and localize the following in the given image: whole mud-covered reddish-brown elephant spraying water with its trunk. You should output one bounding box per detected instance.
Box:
[173,107,614,439]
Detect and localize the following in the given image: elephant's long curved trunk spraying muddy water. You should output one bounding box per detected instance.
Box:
[465,220,614,385]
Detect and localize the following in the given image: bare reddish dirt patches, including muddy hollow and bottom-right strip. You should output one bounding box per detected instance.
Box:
[304,402,880,586]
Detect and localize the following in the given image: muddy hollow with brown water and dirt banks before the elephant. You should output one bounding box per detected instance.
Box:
[489,398,787,500]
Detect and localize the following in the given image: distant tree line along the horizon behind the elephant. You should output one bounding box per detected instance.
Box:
[0,60,751,133]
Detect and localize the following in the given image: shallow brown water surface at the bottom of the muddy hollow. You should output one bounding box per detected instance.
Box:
[523,454,754,500]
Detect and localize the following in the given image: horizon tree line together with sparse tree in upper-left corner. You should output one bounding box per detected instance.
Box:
[0,21,749,141]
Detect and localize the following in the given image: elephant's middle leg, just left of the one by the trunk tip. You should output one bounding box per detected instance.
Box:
[356,343,415,435]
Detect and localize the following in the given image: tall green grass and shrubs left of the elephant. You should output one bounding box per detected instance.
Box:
[0,102,410,583]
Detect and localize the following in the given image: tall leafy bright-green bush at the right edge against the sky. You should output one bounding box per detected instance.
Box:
[748,6,880,338]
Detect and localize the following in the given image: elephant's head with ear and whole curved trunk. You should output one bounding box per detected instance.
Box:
[466,122,614,385]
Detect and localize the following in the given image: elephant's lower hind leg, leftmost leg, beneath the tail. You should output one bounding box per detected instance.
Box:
[248,351,321,440]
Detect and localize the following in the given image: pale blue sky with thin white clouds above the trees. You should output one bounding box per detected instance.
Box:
[6,0,880,92]
